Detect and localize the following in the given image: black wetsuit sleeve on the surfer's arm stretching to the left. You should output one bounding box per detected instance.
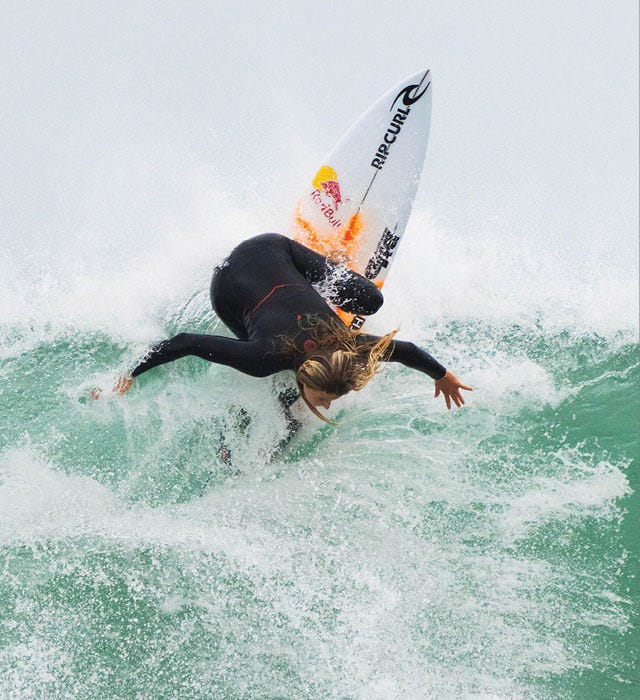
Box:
[131,333,287,377]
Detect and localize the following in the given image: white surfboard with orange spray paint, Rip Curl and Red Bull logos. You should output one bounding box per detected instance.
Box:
[290,70,432,328]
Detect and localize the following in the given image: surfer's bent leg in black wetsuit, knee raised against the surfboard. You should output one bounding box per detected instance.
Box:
[288,240,383,316]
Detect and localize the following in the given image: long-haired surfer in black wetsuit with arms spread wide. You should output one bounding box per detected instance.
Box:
[107,233,472,422]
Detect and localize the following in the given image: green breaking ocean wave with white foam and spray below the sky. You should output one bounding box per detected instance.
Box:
[0,194,640,700]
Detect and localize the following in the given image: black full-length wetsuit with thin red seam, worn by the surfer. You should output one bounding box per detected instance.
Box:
[132,233,446,379]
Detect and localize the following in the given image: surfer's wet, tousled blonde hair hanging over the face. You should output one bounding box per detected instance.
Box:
[289,318,398,425]
